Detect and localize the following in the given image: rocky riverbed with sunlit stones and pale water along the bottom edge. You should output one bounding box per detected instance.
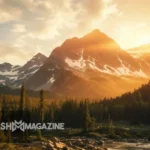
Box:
[42,137,150,150]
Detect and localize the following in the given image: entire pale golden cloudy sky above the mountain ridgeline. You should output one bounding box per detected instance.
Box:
[0,0,150,65]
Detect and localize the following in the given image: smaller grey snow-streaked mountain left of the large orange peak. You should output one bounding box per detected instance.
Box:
[0,53,47,88]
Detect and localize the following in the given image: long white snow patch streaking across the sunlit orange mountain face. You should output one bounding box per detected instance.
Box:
[65,50,148,78]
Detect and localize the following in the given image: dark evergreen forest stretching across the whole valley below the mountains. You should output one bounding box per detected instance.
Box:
[0,83,150,141]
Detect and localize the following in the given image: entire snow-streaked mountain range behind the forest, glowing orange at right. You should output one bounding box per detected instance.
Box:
[0,30,150,98]
